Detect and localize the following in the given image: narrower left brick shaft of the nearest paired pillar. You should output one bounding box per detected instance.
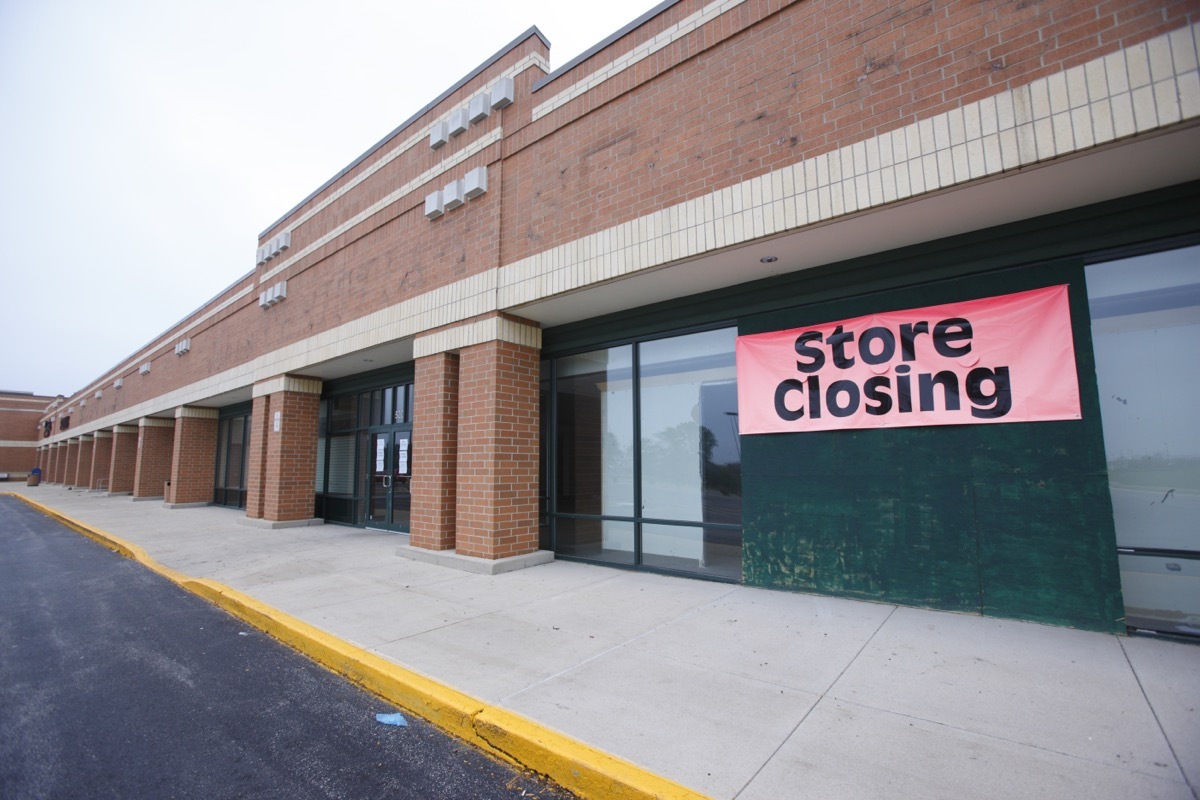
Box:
[409,353,458,551]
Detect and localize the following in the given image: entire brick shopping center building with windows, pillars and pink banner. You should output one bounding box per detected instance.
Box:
[37,0,1200,633]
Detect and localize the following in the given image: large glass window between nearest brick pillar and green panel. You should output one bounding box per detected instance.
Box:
[551,329,742,579]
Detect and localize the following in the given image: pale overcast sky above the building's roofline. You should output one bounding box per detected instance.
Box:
[0,0,656,396]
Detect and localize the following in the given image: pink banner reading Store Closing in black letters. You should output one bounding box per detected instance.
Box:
[737,285,1080,433]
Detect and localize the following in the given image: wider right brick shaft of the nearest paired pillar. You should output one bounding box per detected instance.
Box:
[455,341,540,559]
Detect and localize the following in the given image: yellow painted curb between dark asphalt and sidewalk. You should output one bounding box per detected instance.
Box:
[0,492,709,800]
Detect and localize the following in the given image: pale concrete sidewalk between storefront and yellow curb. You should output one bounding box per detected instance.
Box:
[0,485,1200,800]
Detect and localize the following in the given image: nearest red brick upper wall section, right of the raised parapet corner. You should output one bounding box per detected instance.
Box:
[502,0,1200,263]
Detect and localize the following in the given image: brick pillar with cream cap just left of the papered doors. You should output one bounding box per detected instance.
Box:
[246,375,322,523]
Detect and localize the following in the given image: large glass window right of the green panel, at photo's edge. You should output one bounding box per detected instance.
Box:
[1086,247,1200,634]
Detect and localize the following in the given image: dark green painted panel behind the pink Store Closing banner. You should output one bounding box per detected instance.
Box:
[740,263,1123,631]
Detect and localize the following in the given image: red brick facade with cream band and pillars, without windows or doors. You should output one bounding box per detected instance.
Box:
[28,0,1200,585]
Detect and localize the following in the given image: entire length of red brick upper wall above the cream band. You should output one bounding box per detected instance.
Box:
[42,0,1200,443]
